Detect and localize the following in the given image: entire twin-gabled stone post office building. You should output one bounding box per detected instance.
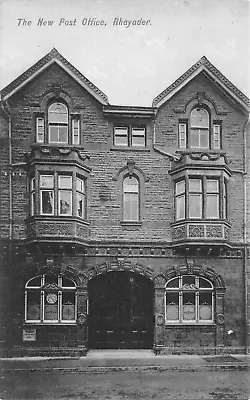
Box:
[0,49,250,356]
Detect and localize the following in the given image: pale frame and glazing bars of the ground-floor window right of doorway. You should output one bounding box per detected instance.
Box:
[164,274,215,325]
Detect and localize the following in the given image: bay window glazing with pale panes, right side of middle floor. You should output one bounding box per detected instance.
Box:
[175,176,227,220]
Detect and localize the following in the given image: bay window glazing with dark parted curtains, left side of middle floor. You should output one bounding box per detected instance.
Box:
[30,172,86,218]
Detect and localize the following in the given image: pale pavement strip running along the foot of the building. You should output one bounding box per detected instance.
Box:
[0,350,250,374]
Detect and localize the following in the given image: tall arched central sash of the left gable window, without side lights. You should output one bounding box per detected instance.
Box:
[48,102,68,143]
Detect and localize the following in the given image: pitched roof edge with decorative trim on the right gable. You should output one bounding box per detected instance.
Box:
[152,56,250,111]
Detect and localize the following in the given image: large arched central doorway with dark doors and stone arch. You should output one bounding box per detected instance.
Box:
[78,261,154,348]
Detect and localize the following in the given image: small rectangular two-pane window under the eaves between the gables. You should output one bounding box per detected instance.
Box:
[114,125,146,147]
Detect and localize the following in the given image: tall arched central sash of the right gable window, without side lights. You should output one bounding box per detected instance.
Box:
[190,108,209,148]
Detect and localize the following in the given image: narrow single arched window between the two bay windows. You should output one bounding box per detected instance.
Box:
[123,176,139,221]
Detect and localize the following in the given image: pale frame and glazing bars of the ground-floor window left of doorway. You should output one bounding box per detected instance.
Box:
[24,274,77,325]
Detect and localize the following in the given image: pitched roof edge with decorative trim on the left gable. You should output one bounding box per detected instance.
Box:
[0,48,108,105]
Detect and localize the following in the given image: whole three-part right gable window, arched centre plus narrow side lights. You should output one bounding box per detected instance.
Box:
[179,107,221,149]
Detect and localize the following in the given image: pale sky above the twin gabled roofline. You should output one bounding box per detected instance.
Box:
[0,0,250,106]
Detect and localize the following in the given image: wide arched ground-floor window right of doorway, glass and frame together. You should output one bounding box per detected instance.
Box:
[165,275,214,324]
